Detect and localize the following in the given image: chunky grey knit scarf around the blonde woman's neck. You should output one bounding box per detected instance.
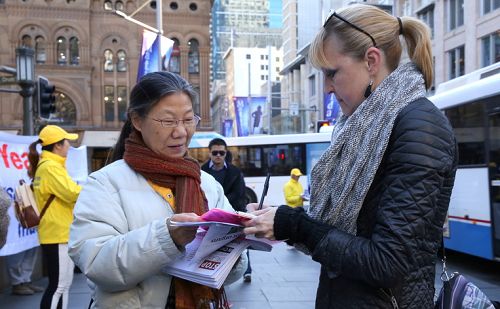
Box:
[308,63,425,235]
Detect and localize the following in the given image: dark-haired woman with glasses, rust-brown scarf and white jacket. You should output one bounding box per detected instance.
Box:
[69,72,246,308]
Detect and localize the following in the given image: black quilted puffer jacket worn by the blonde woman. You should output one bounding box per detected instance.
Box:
[274,99,458,309]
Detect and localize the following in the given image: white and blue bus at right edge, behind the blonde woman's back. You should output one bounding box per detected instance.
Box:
[429,63,500,261]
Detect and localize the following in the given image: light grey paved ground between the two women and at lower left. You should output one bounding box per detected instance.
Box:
[0,243,320,309]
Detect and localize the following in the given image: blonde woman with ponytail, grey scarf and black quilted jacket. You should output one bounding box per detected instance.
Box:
[245,4,457,308]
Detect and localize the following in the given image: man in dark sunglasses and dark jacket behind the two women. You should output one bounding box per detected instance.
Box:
[201,138,252,282]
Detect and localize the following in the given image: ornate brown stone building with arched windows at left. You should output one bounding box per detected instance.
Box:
[0,0,212,165]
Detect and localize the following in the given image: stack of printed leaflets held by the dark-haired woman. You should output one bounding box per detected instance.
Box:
[164,209,272,289]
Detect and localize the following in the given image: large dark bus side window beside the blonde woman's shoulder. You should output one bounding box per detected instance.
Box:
[445,102,486,166]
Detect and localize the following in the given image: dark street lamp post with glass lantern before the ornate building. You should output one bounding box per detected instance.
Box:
[16,46,35,135]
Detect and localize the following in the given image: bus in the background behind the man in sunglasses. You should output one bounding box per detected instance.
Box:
[189,132,332,205]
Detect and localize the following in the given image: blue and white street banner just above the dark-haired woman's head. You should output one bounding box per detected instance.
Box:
[137,30,174,81]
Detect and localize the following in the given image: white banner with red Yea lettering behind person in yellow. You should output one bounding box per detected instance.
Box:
[0,132,88,256]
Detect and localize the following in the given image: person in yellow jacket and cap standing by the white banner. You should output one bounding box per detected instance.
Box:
[28,125,82,309]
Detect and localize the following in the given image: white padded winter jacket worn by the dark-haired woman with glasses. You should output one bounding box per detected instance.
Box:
[69,160,247,309]
